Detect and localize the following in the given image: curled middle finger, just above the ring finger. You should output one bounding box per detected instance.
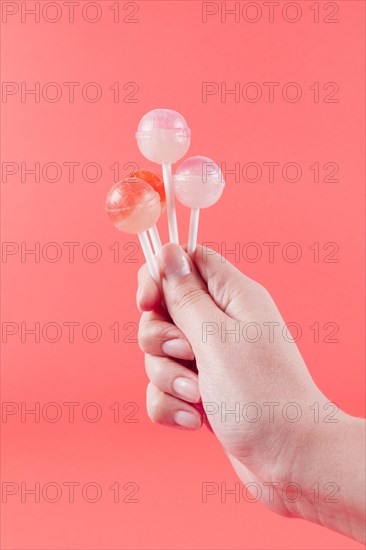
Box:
[138,310,194,361]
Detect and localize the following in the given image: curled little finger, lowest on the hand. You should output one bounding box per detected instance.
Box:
[146,382,202,430]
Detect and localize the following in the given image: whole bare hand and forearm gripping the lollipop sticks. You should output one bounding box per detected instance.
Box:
[137,244,366,542]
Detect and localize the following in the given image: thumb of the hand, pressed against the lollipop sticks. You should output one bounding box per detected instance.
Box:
[158,244,226,357]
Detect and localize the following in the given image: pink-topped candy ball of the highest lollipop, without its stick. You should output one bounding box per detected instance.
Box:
[136,109,191,164]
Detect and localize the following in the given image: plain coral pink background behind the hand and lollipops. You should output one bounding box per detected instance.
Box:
[1,0,365,550]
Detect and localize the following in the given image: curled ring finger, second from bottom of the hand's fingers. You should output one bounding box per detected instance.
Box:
[145,355,200,403]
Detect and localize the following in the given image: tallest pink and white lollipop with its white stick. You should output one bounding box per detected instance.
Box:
[136,109,191,244]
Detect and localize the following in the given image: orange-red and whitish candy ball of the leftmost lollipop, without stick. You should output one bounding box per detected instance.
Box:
[105,178,161,235]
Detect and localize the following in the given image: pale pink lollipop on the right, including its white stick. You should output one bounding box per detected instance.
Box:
[174,157,225,256]
